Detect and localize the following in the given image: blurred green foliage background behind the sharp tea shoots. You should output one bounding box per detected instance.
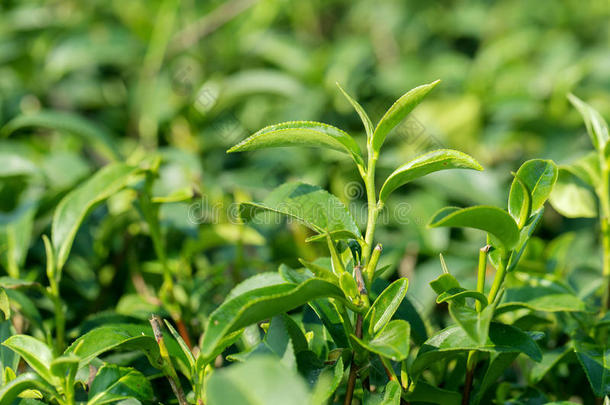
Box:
[0,0,610,334]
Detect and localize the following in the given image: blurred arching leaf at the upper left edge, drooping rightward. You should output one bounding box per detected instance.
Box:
[2,111,121,160]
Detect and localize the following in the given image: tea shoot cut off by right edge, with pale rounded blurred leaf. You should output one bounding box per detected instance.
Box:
[551,94,610,398]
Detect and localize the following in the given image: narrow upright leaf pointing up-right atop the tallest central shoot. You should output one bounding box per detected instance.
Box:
[372,80,440,153]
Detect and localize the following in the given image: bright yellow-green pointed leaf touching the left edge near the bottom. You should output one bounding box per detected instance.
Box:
[2,335,56,384]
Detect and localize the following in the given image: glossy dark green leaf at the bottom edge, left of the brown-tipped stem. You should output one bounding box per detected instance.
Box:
[87,364,154,405]
